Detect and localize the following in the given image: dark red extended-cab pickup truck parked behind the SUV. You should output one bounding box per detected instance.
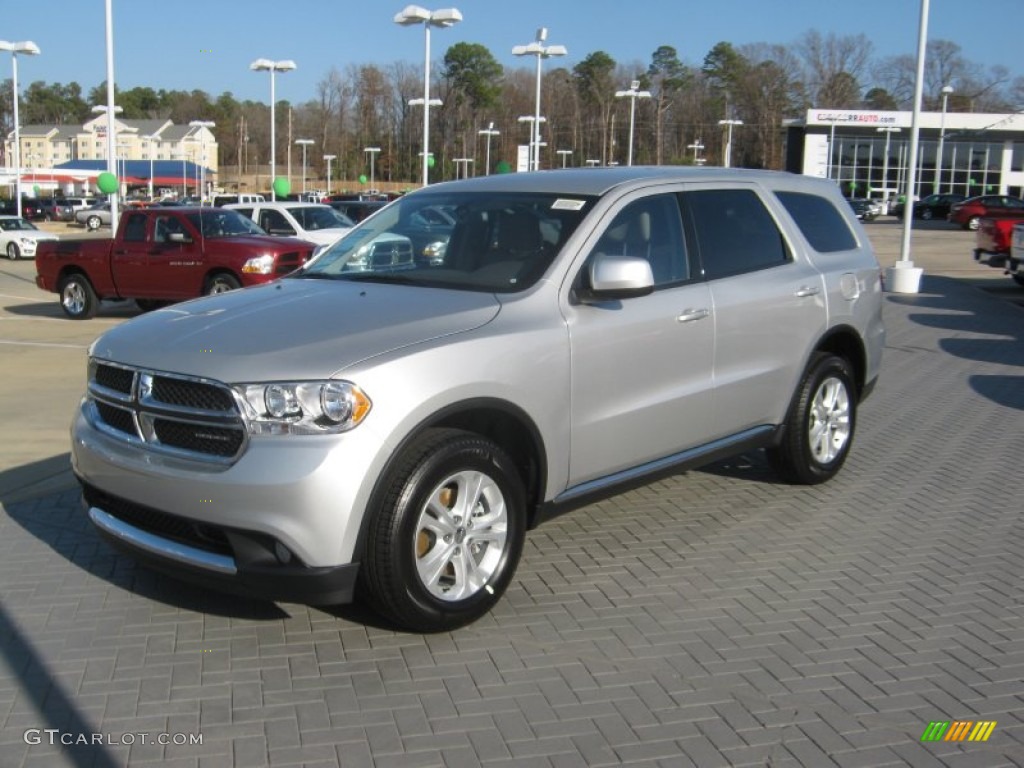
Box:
[36,208,314,319]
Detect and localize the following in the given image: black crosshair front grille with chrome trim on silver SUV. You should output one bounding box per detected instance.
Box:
[86,360,248,464]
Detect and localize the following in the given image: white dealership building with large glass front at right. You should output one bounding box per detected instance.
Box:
[785,109,1024,199]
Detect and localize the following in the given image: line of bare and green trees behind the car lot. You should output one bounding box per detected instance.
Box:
[0,30,1024,181]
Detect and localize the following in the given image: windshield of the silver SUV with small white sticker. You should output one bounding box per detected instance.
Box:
[294,191,593,293]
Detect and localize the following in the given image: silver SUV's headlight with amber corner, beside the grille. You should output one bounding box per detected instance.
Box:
[236,381,372,435]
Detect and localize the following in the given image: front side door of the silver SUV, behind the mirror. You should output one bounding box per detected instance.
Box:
[564,193,714,487]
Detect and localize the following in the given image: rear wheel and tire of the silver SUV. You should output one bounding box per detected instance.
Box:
[767,352,857,485]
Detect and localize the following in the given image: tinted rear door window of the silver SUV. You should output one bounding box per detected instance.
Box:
[681,189,790,280]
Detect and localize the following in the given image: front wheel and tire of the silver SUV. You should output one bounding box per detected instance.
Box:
[360,429,526,632]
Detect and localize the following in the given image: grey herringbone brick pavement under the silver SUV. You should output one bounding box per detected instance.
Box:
[0,278,1024,768]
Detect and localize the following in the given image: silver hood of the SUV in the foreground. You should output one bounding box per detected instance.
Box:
[91,280,501,384]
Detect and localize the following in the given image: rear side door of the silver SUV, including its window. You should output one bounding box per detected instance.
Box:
[681,184,827,437]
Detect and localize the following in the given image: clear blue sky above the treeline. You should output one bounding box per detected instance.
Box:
[0,0,1024,103]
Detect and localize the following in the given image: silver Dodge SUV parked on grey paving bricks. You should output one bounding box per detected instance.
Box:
[73,168,885,631]
